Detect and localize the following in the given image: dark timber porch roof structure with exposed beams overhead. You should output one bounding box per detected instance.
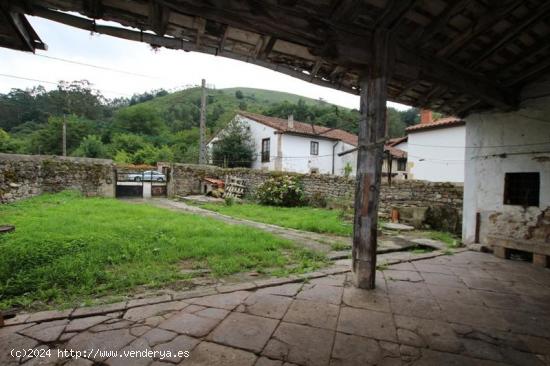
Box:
[0,0,550,116]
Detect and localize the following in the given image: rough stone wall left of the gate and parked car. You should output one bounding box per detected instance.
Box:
[0,154,115,203]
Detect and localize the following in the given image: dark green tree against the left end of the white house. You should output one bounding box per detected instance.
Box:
[212,119,254,168]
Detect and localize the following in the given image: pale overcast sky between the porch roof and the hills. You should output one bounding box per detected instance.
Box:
[0,17,408,109]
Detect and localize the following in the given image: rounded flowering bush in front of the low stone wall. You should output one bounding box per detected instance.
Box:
[256,175,305,207]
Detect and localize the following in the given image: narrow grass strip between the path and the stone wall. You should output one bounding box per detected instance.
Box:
[200,203,353,236]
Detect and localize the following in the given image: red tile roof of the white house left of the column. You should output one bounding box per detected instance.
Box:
[237,111,358,146]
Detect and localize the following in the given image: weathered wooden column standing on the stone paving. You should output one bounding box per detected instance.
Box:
[352,30,394,289]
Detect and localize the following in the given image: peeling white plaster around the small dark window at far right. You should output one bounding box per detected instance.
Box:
[462,98,550,243]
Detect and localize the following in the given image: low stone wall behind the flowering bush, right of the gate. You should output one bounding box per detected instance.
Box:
[165,164,463,233]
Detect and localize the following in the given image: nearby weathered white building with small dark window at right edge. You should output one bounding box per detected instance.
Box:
[462,91,550,258]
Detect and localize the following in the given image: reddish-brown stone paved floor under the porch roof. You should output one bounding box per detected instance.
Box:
[0,252,550,366]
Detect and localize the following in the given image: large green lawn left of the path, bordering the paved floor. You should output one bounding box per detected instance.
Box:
[0,192,324,308]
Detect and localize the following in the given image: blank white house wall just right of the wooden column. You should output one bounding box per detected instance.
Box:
[408,126,466,183]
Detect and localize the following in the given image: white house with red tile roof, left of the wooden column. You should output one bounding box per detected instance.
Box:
[207,112,357,175]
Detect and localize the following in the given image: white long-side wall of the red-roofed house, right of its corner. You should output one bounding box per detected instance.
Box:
[282,134,337,174]
